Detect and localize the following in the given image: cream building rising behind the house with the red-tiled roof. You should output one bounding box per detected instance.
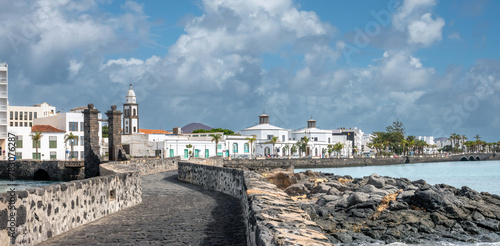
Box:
[8,102,56,127]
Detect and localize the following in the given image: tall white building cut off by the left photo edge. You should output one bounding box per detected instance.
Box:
[0,63,9,160]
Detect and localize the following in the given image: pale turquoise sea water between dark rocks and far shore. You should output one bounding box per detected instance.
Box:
[295,161,500,195]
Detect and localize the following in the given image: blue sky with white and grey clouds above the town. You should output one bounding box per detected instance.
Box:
[0,0,500,142]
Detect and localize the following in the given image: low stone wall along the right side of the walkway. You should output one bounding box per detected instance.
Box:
[178,162,330,245]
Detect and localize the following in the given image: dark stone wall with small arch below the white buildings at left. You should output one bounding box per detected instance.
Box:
[0,160,85,181]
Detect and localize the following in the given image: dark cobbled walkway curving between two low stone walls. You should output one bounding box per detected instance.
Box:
[39,170,246,245]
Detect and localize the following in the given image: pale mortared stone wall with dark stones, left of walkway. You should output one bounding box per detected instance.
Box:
[0,165,142,245]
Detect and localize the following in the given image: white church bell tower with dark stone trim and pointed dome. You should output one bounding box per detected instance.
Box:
[123,84,139,135]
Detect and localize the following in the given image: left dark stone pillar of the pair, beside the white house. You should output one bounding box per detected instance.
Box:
[83,103,103,178]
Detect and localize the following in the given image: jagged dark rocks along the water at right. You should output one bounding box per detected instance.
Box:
[285,171,500,244]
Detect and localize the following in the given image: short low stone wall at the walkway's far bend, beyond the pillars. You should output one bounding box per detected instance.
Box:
[99,157,181,176]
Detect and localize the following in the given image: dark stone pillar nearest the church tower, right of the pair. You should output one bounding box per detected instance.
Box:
[106,105,122,161]
